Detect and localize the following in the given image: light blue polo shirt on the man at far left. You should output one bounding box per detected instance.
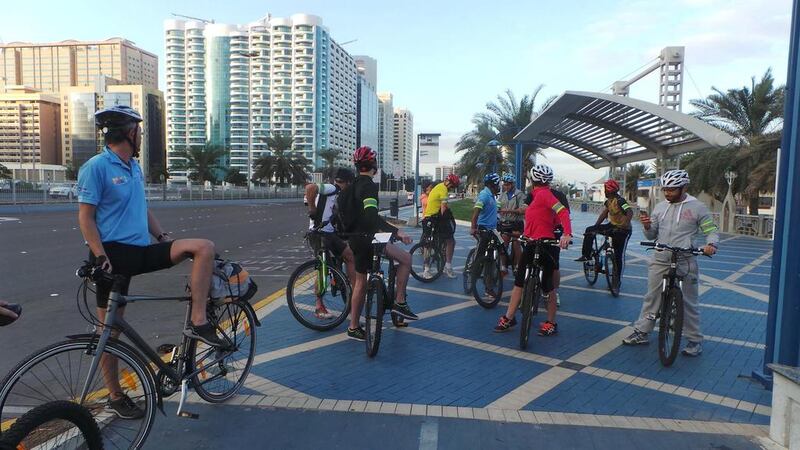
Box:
[78,147,150,246]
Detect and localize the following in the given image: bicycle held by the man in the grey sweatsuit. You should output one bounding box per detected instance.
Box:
[639,242,710,367]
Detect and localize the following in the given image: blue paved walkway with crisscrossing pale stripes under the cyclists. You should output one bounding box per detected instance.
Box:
[151,213,771,448]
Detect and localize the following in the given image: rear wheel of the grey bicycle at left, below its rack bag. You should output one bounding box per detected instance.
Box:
[189,301,256,403]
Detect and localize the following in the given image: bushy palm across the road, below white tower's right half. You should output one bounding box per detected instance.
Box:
[253,133,311,186]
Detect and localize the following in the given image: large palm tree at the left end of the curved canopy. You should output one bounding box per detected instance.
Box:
[456,85,555,187]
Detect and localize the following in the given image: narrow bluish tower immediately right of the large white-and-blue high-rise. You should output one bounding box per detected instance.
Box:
[354,55,379,155]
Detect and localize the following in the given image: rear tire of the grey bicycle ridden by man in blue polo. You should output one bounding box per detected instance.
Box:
[189,301,256,403]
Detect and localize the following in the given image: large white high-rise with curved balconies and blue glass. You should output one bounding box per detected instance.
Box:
[164,14,357,180]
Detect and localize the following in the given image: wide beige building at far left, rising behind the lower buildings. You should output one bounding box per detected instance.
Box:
[0,38,158,93]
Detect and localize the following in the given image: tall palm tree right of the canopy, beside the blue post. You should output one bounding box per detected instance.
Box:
[690,69,785,214]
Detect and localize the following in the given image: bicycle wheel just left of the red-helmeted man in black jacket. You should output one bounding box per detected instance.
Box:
[286,259,352,331]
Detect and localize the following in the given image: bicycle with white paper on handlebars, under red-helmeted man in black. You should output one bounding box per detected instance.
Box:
[364,233,406,358]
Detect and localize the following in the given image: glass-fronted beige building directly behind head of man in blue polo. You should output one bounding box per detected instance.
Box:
[60,77,166,178]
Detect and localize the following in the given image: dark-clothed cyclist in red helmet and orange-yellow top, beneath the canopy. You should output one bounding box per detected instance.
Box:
[575,180,633,283]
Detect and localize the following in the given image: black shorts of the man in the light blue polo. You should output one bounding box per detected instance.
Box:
[89,241,174,308]
